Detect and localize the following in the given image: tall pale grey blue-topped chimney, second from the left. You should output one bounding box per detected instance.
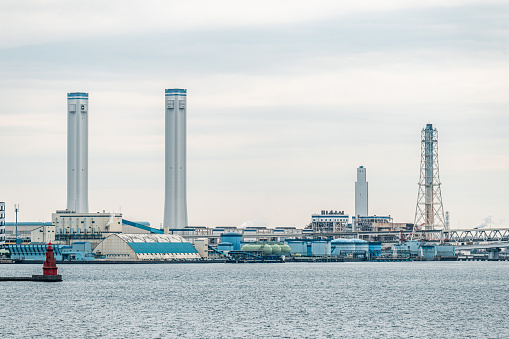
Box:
[163,88,188,233]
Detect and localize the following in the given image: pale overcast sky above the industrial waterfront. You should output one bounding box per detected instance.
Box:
[0,0,509,228]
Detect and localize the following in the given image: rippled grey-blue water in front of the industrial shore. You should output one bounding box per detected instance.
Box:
[0,262,509,338]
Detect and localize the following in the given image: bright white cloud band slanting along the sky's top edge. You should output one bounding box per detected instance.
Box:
[0,0,503,47]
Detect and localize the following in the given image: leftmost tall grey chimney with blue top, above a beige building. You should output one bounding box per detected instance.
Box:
[67,92,88,213]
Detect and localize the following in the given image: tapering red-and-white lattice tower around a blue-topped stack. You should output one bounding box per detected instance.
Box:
[414,124,446,230]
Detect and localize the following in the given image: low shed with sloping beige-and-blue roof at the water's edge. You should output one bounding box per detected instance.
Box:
[94,234,200,260]
